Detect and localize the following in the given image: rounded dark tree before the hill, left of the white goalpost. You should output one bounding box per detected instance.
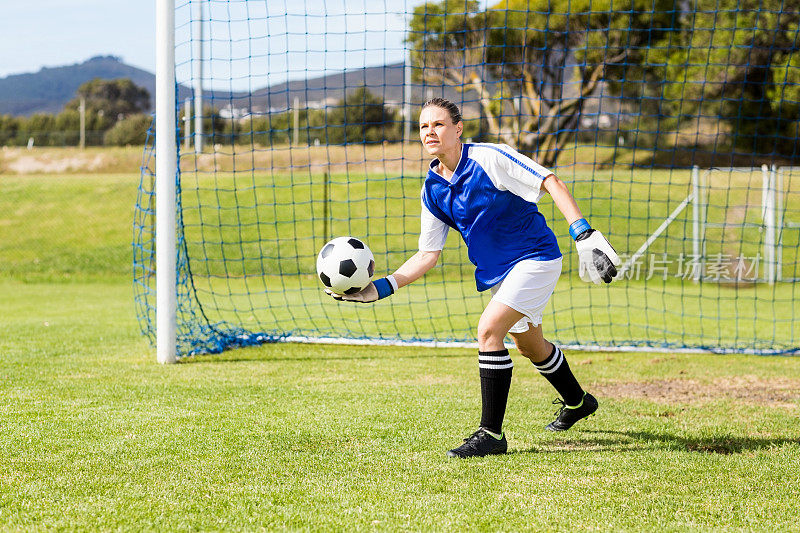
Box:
[65,78,150,122]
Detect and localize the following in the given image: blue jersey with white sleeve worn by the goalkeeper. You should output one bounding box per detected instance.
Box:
[422,143,561,291]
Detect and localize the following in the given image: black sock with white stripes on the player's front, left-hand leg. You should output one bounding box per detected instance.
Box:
[478,350,514,433]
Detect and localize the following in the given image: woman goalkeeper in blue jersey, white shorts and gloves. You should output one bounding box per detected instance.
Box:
[326,98,620,458]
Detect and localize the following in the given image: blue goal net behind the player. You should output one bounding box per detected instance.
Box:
[134,0,800,356]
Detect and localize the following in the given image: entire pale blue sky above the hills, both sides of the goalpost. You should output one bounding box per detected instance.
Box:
[0,0,450,88]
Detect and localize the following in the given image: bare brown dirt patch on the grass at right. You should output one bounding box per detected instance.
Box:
[594,376,800,408]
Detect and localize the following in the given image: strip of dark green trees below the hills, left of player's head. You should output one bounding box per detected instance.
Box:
[0,79,438,146]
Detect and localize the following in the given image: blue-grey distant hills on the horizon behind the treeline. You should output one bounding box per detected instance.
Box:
[0,56,461,116]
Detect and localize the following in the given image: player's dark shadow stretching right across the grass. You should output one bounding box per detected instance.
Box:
[512,430,800,455]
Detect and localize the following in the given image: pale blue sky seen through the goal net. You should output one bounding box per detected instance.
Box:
[175,0,420,90]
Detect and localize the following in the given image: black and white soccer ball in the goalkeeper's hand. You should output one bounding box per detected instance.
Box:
[317,237,375,294]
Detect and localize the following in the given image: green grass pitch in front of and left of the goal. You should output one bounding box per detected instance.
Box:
[0,154,800,531]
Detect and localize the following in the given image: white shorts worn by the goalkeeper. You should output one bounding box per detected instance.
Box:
[492,257,562,333]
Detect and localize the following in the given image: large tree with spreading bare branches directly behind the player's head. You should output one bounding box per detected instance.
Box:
[408,0,676,166]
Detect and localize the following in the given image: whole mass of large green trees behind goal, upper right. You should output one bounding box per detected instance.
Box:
[408,0,800,165]
